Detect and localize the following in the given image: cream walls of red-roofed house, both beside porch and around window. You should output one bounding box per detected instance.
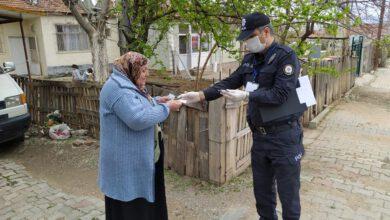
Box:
[0,16,120,75]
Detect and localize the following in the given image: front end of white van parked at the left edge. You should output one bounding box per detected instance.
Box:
[0,62,30,143]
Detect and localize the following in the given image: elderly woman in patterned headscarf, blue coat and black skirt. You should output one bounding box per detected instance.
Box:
[99,52,181,220]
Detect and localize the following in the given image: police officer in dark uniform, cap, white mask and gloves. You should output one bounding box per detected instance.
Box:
[179,13,304,219]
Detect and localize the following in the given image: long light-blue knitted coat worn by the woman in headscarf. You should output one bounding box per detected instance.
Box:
[98,69,169,202]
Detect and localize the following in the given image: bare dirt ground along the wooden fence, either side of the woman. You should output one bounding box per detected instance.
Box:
[0,126,255,219]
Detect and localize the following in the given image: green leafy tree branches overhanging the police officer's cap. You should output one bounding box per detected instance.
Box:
[115,0,350,74]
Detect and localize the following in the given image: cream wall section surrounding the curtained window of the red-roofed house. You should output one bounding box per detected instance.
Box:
[40,16,120,75]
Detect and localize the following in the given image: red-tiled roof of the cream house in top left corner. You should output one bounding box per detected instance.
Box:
[0,0,70,14]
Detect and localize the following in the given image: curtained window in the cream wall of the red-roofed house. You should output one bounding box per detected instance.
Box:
[56,25,89,51]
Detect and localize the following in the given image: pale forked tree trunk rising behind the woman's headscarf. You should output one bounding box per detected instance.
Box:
[62,0,111,82]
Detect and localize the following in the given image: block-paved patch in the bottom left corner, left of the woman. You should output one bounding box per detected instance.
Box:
[0,160,105,220]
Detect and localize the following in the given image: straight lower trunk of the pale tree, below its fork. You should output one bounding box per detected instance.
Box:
[89,33,109,83]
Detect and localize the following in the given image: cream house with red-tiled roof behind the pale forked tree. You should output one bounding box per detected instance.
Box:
[0,0,120,76]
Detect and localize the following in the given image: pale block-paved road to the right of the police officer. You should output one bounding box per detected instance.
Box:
[302,65,390,220]
